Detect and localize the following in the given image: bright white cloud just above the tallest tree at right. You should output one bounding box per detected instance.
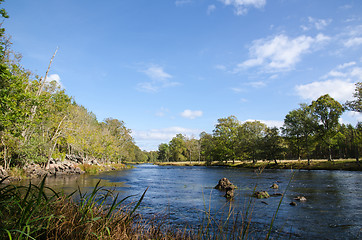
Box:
[295,79,355,102]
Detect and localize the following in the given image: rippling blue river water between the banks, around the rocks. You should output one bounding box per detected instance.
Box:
[19,164,362,239]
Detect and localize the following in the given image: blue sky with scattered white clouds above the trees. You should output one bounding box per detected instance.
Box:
[2,0,362,150]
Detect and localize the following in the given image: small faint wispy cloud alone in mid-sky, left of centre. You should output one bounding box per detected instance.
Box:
[137,65,179,92]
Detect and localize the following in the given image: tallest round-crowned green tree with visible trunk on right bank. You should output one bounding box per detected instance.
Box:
[311,94,344,161]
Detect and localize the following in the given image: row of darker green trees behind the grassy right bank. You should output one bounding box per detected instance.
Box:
[153,86,362,163]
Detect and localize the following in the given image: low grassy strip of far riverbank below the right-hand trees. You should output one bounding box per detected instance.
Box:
[154,159,362,171]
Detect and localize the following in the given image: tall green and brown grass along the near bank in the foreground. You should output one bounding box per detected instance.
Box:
[0,170,291,240]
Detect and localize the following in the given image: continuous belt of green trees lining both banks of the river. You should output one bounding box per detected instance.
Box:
[0,0,362,179]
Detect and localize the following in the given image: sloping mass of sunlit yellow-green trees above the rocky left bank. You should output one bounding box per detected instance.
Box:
[0,6,147,169]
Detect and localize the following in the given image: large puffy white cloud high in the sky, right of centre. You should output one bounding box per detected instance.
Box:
[235,34,330,72]
